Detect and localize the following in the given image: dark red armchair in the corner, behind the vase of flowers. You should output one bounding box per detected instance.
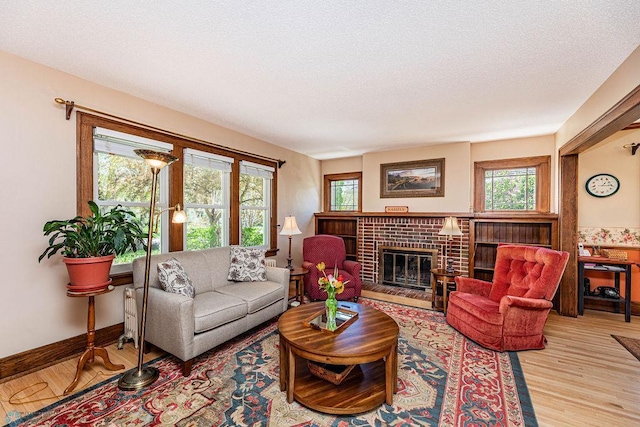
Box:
[302,234,362,301]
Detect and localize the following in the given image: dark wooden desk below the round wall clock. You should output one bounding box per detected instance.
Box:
[578,256,636,322]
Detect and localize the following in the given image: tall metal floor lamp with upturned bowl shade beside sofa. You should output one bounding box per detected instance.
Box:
[118,150,178,390]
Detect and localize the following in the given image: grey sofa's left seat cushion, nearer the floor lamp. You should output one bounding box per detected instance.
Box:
[193,292,247,333]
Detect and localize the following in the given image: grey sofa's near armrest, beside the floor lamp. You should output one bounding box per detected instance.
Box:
[136,287,195,360]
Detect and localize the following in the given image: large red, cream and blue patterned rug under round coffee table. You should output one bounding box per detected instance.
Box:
[8,298,537,427]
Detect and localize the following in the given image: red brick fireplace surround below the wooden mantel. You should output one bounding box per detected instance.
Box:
[357,215,469,284]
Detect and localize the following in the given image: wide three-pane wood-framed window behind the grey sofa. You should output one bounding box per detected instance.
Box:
[77,112,277,285]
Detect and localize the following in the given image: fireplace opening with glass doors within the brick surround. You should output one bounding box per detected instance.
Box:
[378,246,438,290]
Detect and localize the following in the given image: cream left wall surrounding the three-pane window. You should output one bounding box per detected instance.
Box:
[0,52,322,357]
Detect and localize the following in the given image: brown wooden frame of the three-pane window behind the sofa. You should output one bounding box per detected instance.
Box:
[76,111,278,285]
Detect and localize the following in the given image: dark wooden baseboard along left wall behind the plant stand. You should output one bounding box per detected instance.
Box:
[0,323,124,382]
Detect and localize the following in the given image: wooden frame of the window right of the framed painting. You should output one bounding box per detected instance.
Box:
[473,156,551,214]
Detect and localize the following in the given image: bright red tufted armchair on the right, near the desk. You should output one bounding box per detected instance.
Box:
[447,245,569,351]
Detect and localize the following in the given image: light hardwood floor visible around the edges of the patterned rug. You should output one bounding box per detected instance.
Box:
[0,290,640,427]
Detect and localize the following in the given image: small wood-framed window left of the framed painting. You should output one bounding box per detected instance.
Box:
[324,172,362,212]
